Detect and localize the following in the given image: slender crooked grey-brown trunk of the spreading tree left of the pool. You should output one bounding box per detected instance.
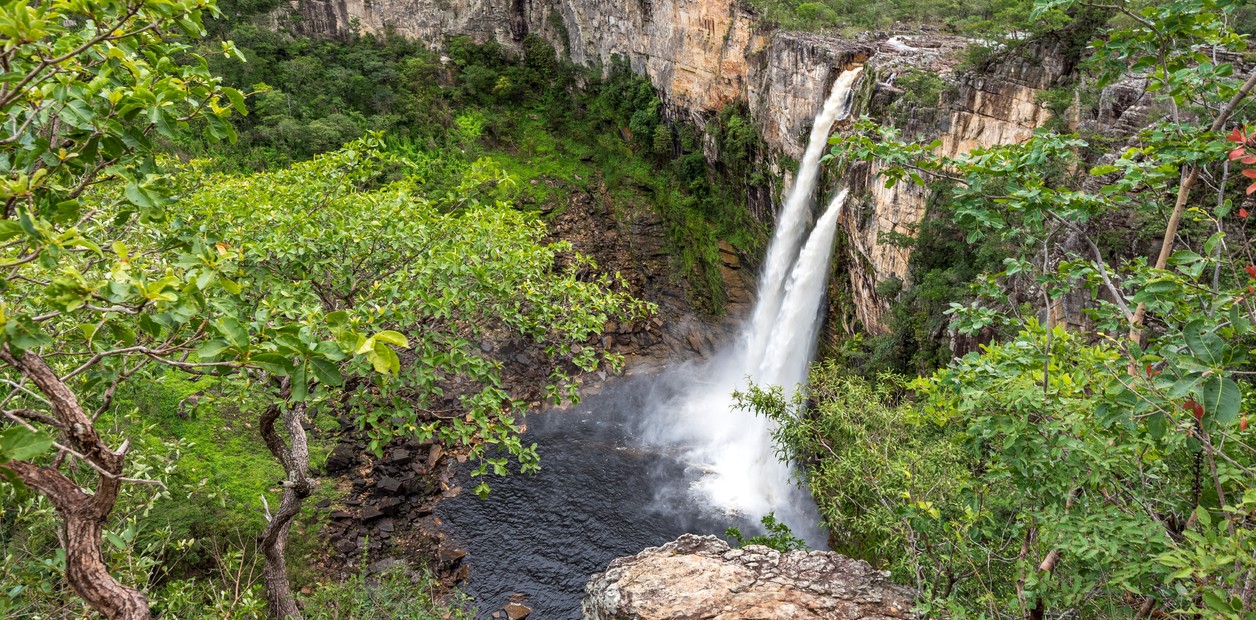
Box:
[259,394,314,620]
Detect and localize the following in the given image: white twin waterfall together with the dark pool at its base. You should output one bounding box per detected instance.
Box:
[437,68,862,619]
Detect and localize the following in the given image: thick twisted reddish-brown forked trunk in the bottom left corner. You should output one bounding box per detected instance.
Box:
[0,348,152,620]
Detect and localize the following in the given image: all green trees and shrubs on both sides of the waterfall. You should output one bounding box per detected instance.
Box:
[0,0,1256,619]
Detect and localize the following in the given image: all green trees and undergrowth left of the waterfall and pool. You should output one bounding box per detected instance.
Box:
[0,0,678,617]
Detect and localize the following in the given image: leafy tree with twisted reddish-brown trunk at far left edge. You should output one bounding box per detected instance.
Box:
[0,0,252,617]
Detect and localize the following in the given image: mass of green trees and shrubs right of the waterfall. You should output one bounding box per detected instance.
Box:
[741,0,1256,619]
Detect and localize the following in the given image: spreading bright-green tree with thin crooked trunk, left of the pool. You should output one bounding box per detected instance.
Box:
[168,137,648,617]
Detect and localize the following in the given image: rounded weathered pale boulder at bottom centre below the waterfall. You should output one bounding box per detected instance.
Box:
[583,535,916,620]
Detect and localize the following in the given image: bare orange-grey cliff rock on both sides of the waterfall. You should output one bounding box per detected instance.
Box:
[290,0,1065,331]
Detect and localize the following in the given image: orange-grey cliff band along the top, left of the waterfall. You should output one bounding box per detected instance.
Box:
[290,0,854,151]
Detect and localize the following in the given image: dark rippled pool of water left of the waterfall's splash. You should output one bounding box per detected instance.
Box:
[437,378,759,620]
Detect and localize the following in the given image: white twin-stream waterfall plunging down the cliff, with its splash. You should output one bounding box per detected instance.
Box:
[647,68,862,545]
